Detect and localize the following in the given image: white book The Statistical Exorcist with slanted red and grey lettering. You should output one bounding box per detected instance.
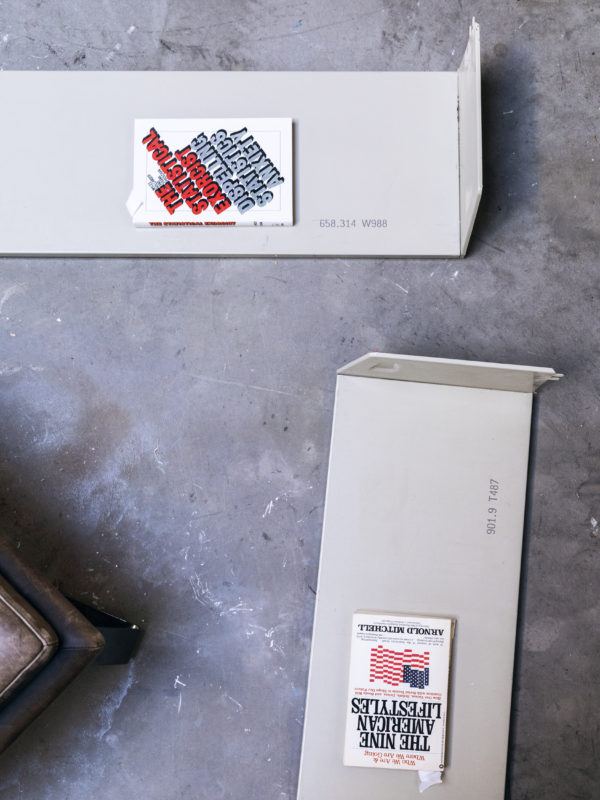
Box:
[127,118,294,228]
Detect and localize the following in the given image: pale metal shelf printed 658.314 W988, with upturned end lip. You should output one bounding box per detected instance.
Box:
[0,21,482,257]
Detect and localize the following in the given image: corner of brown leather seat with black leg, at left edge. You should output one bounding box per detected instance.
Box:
[0,539,140,752]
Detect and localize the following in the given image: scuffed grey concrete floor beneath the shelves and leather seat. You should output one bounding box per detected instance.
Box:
[0,0,600,800]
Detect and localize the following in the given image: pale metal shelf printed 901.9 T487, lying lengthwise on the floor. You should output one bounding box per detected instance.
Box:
[298,353,560,800]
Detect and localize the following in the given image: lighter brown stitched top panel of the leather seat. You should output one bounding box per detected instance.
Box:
[0,576,58,704]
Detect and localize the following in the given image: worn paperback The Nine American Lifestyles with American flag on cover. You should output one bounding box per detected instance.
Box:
[344,611,454,772]
